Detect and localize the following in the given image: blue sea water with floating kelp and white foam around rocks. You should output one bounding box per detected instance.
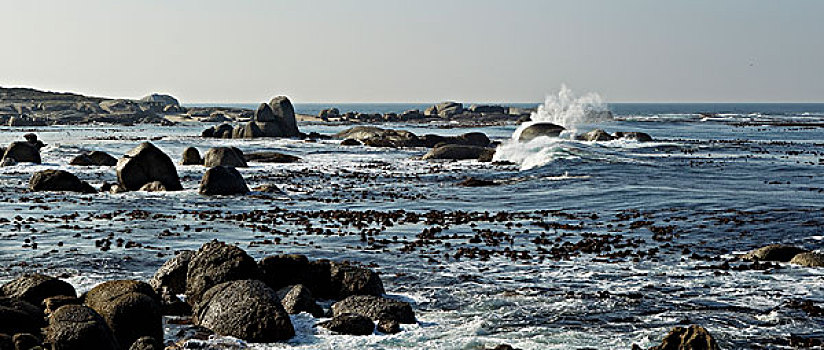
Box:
[0,110,824,349]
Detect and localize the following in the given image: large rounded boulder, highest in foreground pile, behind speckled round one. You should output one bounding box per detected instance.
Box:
[186,241,260,306]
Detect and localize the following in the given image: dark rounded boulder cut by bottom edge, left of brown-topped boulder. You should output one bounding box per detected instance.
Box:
[46,305,120,350]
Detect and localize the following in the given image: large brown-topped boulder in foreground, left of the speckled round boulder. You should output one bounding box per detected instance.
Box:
[84,280,163,344]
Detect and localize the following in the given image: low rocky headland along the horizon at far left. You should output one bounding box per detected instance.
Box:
[0,88,185,126]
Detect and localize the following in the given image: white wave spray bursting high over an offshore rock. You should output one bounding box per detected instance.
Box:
[494,85,612,170]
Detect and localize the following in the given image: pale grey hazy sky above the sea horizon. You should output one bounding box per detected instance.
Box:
[0,0,824,103]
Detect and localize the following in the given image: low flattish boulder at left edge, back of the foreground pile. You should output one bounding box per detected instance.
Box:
[2,273,77,306]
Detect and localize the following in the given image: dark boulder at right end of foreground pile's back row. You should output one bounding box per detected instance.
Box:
[330,262,386,299]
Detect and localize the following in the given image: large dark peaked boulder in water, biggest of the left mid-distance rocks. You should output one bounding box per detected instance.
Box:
[117,142,183,191]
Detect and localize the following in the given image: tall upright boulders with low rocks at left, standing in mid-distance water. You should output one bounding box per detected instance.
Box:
[201,96,301,139]
